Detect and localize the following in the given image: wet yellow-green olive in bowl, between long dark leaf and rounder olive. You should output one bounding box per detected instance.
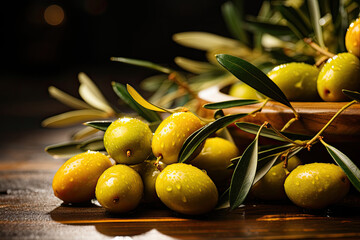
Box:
[267,62,319,102]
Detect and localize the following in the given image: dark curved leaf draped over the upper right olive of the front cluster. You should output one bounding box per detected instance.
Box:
[178,113,247,163]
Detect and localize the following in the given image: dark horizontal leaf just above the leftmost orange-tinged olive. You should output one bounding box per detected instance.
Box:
[45,137,105,158]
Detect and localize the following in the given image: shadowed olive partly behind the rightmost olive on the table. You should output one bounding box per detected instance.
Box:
[251,156,301,201]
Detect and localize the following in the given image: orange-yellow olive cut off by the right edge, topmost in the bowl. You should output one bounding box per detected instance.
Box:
[345,18,360,57]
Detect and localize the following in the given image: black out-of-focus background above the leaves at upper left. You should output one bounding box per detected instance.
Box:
[0,0,260,131]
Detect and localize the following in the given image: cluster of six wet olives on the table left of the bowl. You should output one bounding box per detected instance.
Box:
[53,112,239,215]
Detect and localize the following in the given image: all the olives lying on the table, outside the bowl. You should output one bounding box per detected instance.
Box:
[53,112,350,215]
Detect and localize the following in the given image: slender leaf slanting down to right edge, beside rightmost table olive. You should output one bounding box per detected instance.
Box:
[321,141,360,192]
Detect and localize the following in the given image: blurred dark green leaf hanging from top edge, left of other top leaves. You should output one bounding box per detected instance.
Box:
[221,1,249,45]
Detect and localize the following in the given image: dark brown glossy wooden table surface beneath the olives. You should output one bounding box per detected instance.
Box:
[0,128,360,239]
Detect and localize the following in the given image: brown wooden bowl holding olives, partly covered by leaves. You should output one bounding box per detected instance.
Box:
[199,84,360,143]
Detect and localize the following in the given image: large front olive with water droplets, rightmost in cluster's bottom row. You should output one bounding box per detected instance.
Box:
[155,163,218,215]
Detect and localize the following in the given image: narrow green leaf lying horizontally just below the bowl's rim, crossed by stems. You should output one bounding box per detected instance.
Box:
[235,122,311,142]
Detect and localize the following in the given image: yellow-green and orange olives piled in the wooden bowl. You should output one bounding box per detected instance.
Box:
[229,18,360,102]
